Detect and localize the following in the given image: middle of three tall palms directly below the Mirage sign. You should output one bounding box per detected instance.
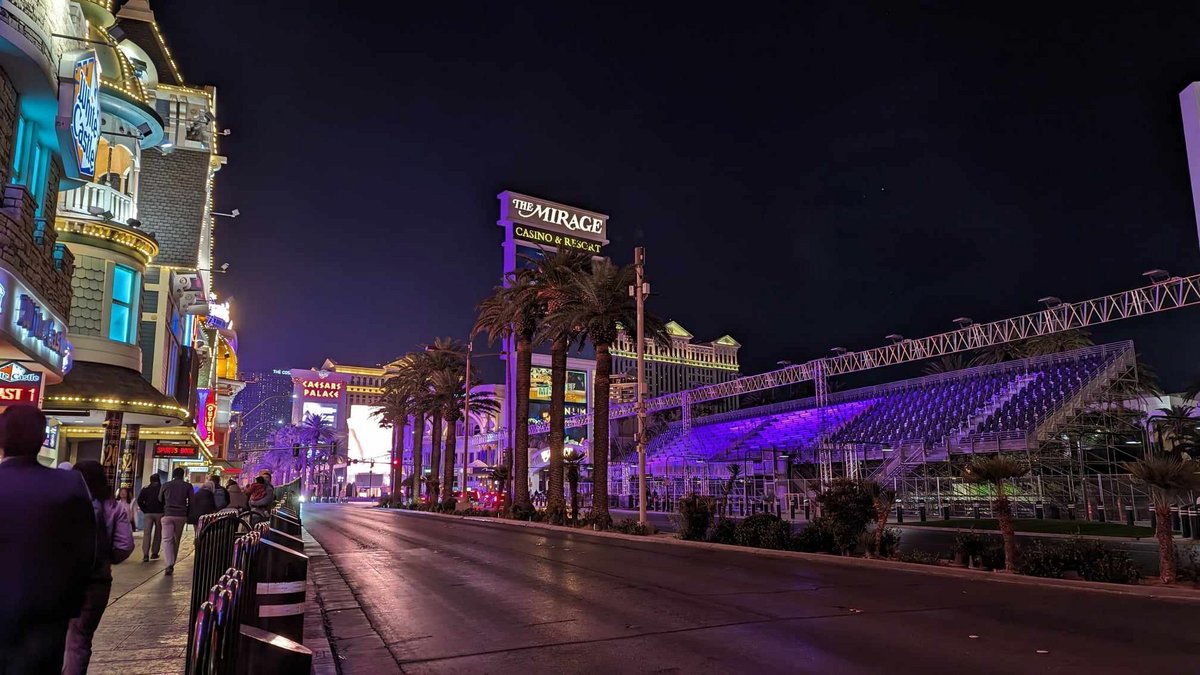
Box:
[527,249,590,525]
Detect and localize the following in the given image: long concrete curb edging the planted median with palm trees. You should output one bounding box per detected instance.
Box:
[385,509,1200,602]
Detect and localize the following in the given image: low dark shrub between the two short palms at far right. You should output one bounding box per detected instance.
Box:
[1018,537,1141,584]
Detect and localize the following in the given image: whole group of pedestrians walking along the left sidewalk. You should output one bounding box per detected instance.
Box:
[0,406,275,675]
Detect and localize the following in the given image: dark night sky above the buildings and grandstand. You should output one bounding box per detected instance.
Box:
[154,0,1200,387]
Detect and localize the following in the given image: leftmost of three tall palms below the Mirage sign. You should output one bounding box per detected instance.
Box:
[472,269,546,510]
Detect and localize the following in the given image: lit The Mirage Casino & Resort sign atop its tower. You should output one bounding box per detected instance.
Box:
[499,191,608,247]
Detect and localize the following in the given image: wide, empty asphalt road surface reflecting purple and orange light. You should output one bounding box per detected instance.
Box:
[305,504,1200,675]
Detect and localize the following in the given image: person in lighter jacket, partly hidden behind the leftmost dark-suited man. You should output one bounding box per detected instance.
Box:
[62,459,133,675]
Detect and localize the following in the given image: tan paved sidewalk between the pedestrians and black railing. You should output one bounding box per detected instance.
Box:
[88,527,194,675]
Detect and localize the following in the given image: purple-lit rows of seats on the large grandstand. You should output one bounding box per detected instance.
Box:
[649,344,1129,461]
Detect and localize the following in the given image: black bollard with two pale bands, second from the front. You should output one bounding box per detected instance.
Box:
[242,532,308,640]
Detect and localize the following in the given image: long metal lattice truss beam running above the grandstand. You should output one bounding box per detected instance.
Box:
[520,274,1200,434]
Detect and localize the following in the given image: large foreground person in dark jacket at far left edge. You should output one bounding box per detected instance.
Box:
[0,406,96,673]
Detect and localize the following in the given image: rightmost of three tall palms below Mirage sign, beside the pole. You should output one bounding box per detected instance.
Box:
[546,258,666,528]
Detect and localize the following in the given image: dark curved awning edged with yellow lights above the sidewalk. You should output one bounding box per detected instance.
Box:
[44,362,191,426]
